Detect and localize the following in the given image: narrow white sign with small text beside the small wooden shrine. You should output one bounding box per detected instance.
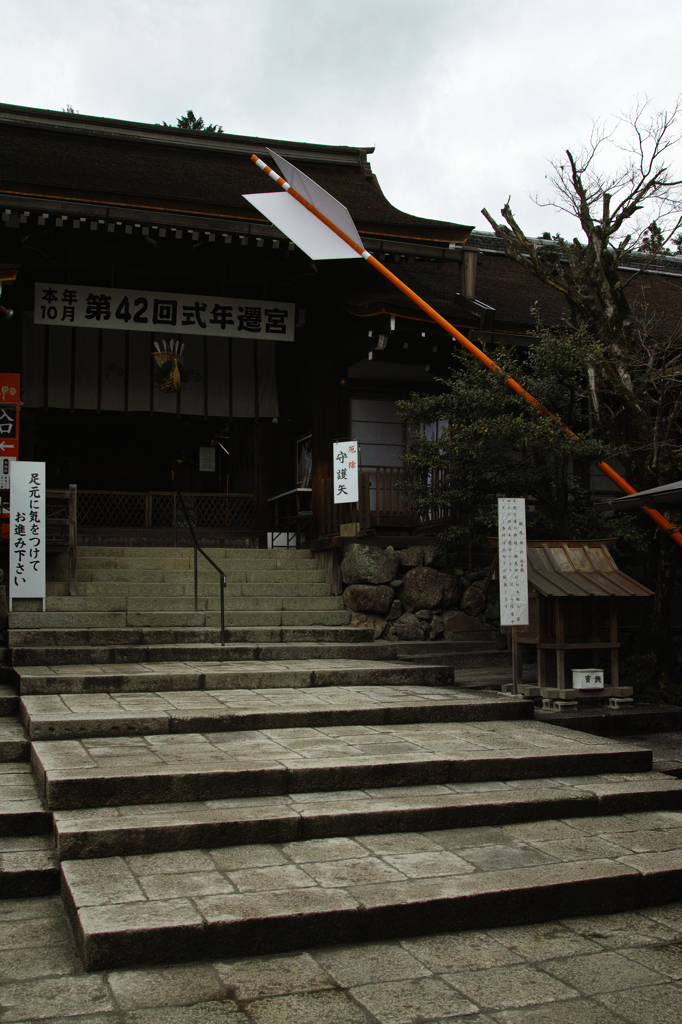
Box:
[498,498,528,626]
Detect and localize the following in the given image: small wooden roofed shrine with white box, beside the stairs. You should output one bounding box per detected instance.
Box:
[489,540,653,703]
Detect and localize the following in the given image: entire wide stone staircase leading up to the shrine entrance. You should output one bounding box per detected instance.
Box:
[0,548,682,969]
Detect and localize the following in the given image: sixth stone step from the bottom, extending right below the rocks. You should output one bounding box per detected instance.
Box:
[11,630,511,672]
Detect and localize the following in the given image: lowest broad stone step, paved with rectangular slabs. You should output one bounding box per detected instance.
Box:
[61,812,682,966]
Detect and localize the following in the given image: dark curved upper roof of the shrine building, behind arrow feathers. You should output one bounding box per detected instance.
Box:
[0,104,471,243]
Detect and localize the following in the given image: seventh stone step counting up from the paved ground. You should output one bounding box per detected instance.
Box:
[9,612,366,649]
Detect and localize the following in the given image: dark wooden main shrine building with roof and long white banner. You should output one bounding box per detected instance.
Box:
[0,104,679,543]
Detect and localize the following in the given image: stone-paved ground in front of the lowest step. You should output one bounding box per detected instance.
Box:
[0,897,682,1024]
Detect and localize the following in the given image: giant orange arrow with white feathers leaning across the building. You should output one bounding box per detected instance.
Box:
[244,150,682,547]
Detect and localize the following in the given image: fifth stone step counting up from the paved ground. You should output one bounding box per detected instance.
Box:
[14,645,453,695]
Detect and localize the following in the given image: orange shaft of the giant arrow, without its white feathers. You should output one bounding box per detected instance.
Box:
[251,154,682,548]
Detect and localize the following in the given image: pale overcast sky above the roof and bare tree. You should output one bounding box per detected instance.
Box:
[0,0,682,233]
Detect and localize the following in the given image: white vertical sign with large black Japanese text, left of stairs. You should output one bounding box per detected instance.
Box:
[9,462,46,608]
